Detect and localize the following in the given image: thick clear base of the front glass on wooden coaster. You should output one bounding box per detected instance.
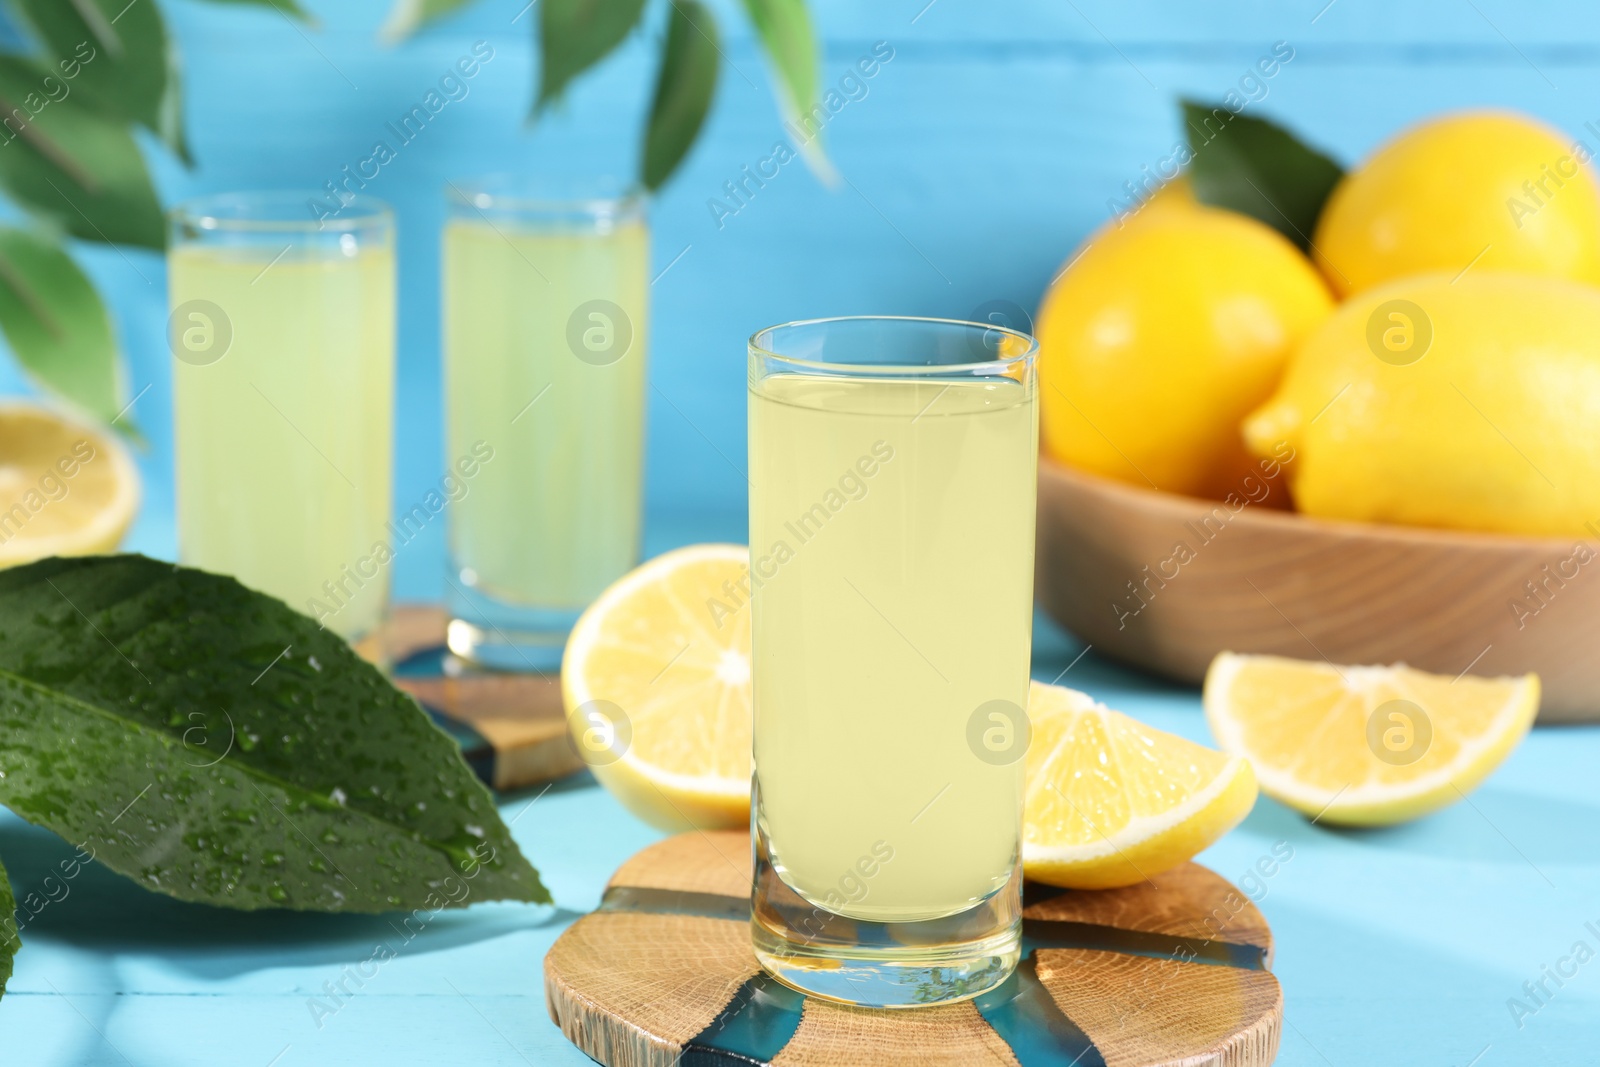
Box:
[750,830,1022,1008]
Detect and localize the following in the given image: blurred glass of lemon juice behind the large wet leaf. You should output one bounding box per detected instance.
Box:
[166,192,395,640]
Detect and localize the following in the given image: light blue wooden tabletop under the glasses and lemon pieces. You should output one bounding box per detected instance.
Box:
[0,517,1600,1067]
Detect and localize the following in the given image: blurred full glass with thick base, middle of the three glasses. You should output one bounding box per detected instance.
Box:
[443,178,650,670]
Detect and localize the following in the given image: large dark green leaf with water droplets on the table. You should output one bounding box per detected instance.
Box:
[0,555,549,912]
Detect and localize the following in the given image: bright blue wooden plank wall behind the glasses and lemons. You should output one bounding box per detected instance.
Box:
[21,0,1600,595]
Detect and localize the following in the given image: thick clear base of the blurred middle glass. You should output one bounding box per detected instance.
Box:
[445,571,582,673]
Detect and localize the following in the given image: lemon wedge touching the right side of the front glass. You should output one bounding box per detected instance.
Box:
[1022,681,1256,889]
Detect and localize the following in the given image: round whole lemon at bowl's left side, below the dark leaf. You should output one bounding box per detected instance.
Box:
[1035,203,1333,499]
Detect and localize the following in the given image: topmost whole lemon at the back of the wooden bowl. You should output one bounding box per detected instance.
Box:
[1312,112,1600,298]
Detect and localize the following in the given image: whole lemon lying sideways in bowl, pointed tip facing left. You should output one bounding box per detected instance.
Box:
[1245,270,1600,536]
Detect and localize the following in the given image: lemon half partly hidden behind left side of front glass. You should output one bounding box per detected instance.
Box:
[562,544,750,830]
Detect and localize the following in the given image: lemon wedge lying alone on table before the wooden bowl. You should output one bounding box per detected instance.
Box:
[1205,653,1539,825]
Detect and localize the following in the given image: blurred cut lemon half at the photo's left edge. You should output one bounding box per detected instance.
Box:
[0,405,139,566]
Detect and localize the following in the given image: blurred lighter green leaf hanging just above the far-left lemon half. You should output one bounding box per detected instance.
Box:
[0,226,122,422]
